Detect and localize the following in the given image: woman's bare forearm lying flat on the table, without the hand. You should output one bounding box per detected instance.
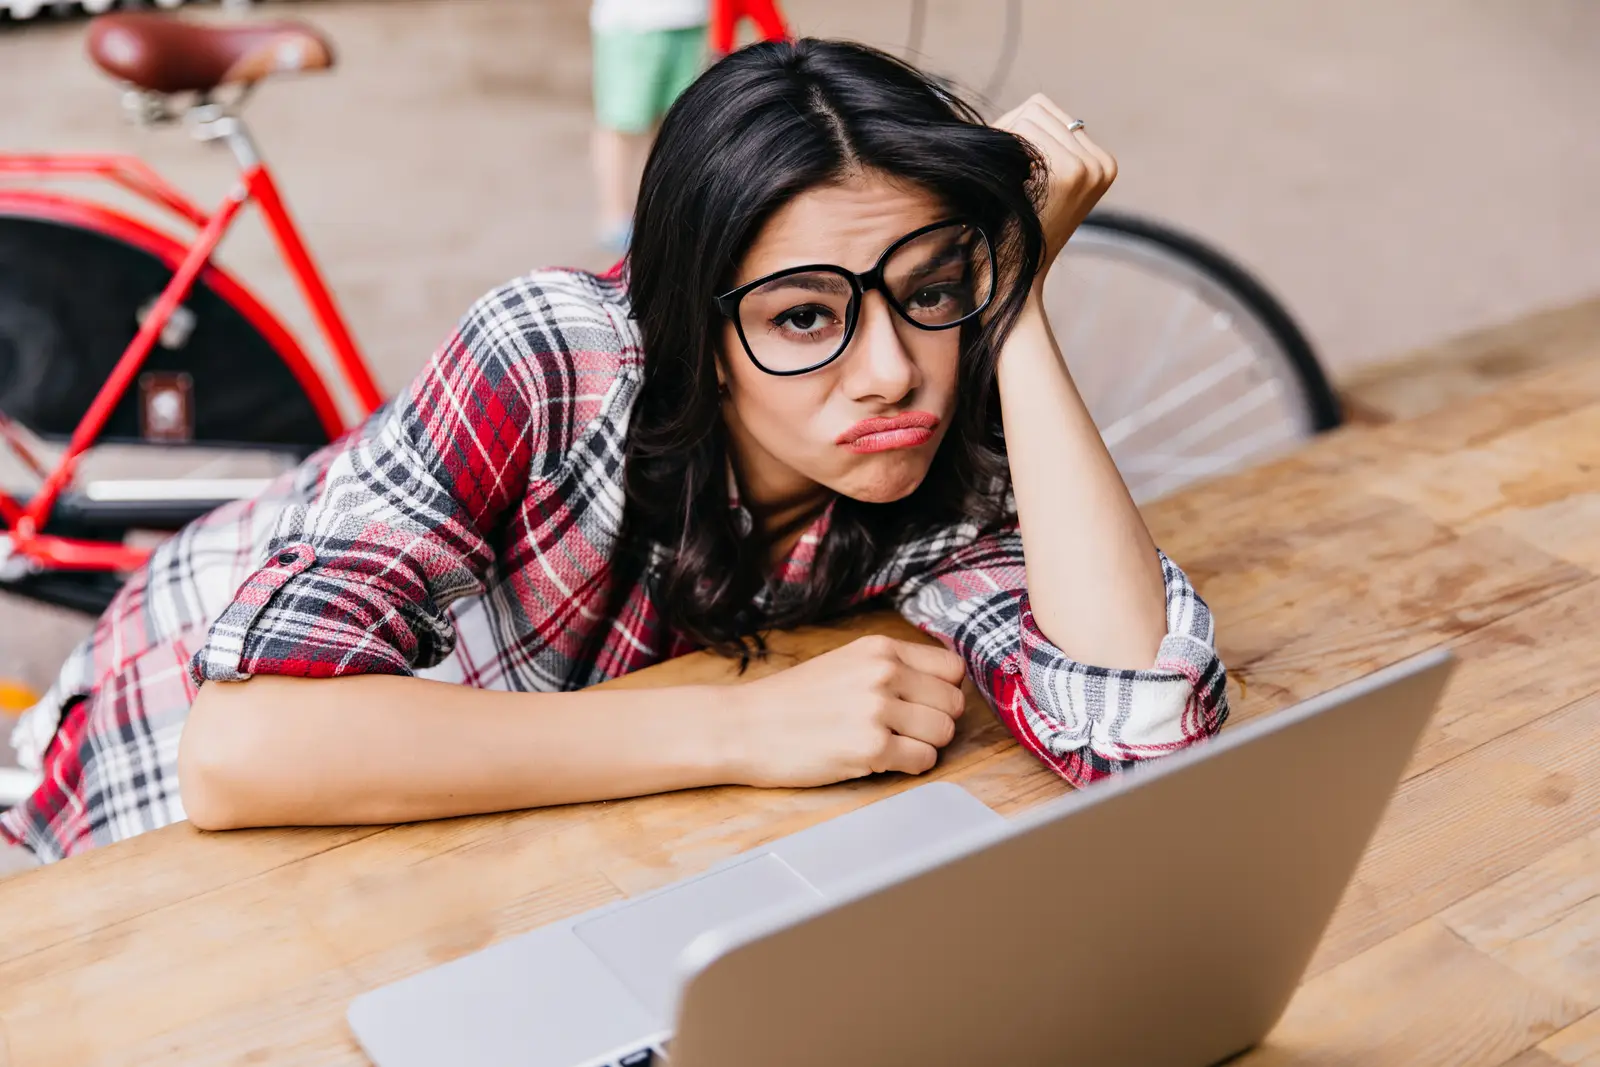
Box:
[178,675,733,830]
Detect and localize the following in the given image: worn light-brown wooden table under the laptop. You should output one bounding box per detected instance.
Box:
[0,363,1600,1067]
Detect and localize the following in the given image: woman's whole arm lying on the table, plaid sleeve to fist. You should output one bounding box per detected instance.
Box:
[179,275,962,829]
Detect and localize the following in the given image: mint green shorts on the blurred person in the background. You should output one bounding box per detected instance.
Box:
[594,26,706,133]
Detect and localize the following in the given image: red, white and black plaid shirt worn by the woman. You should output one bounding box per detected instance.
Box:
[0,270,1227,861]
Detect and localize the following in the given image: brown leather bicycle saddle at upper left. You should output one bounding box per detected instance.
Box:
[88,11,333,93]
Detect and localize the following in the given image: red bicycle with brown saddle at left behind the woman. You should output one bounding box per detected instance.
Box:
[0,13,382,613]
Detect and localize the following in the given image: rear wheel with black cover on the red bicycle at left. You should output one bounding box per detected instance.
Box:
[0,211,331,613]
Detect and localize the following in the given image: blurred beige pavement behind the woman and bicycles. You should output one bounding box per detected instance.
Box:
[0,0,1600,751]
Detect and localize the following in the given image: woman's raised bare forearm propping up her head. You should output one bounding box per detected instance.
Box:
[998,290,1166,669]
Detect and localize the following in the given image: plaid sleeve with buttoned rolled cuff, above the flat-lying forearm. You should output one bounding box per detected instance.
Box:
[190,283,542,683]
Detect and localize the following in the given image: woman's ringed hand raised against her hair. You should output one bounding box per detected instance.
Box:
[995,93,1117,285]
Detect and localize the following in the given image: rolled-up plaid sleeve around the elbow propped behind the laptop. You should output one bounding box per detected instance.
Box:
[898,528,1227,785]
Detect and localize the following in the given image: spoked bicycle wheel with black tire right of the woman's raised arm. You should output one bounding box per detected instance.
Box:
[1045,211,1341,502]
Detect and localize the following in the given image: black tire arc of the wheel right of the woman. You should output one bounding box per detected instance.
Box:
[1078,210,1344,434]
